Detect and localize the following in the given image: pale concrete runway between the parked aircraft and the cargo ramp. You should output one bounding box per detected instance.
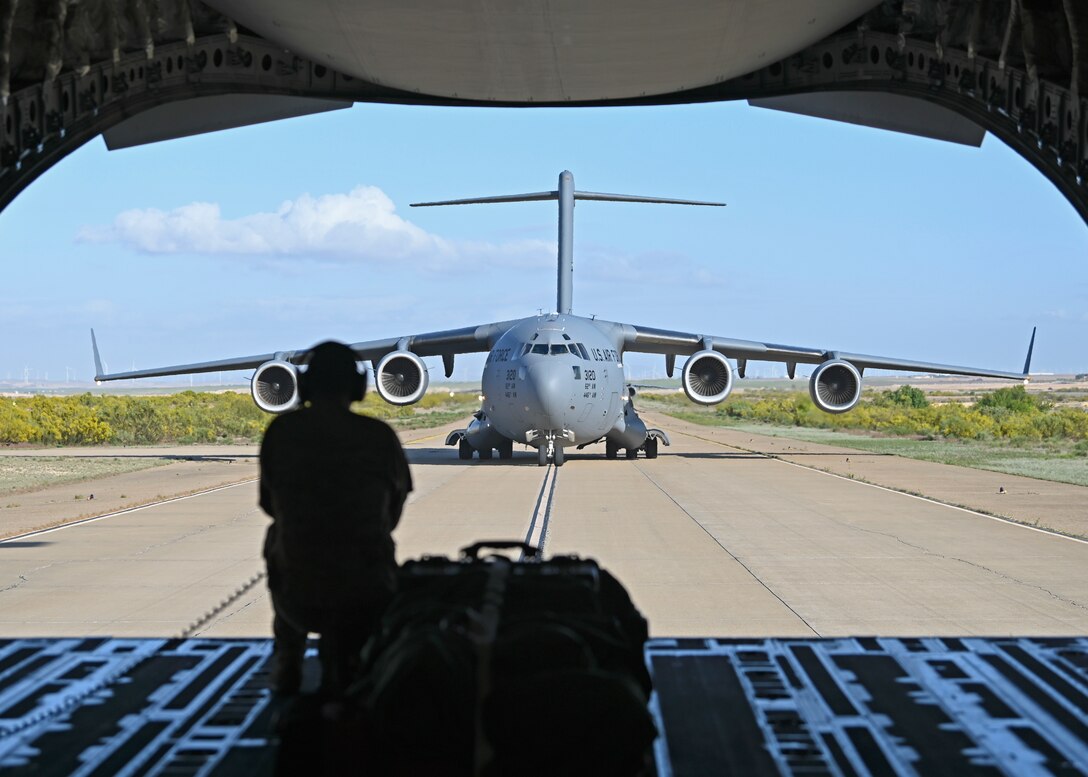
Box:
[0,419,1088,637]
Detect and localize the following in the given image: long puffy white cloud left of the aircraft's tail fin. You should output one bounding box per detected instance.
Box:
[77,186,555,267]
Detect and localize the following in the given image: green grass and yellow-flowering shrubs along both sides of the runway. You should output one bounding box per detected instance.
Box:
[6,389,1088,483]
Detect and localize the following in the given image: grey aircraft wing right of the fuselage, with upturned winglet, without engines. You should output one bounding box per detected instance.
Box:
[613,324,1035,380]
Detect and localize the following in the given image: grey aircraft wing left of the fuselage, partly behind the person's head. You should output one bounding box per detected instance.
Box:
[90,321,517,381]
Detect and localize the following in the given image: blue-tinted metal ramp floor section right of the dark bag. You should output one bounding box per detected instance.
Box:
[647,638,1088,777]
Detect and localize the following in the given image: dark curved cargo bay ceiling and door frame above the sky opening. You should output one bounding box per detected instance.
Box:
[0,0,1088,220]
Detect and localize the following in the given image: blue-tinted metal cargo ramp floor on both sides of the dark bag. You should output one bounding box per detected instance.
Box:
[0,638,1088,777]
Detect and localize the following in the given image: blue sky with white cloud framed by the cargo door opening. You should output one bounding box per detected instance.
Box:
[0,103,1088,380]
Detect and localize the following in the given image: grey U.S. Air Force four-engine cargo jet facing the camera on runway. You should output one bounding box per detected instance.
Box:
[90,171,1035,467]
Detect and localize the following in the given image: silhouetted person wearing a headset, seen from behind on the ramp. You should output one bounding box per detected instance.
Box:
[260,342,411,693]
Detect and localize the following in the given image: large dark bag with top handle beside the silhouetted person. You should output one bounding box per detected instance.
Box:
[351,542,656,777]
